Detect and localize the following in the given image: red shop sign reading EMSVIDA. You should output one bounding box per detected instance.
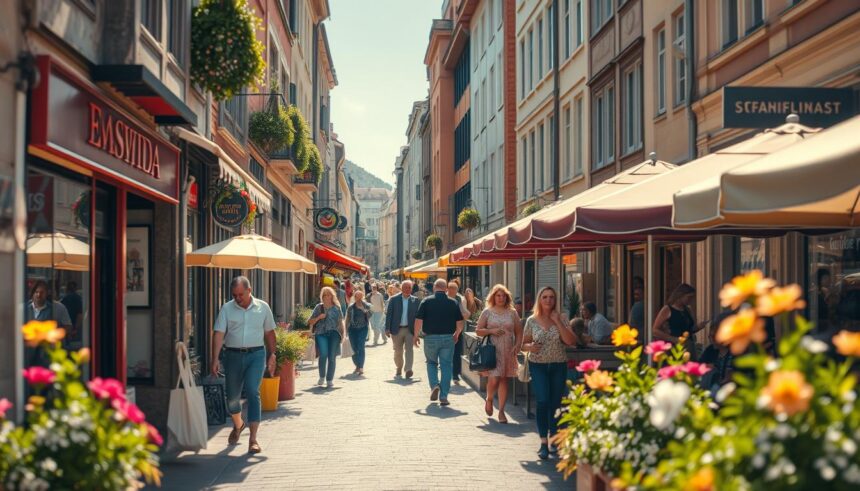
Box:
[31,56,179,203]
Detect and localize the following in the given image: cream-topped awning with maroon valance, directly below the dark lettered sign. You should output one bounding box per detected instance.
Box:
[576,119,819,234]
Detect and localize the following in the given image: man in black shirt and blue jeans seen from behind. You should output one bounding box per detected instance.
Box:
[412,279,463,406]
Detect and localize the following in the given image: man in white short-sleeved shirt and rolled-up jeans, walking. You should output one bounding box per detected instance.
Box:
[212,276,275,454]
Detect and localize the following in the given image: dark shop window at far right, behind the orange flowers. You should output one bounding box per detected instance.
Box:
[808,230,860,332]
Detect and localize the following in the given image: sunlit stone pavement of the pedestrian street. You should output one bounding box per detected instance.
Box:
[155,342,575,491]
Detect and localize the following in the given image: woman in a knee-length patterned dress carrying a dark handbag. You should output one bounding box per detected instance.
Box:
[474,285,523,424]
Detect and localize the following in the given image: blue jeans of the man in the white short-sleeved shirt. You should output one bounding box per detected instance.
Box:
[224,349,266,423]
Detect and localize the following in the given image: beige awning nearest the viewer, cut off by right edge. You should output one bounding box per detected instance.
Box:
[674,116,860,228]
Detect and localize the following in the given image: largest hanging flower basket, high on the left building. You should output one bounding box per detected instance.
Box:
[191,0,266,101]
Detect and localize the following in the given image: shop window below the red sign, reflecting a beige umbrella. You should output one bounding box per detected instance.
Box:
[23,170,92,376]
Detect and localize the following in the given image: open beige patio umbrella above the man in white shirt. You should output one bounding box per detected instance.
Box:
[185,234,317,274]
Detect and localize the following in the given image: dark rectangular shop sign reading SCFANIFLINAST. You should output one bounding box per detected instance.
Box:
[723,87,857,128]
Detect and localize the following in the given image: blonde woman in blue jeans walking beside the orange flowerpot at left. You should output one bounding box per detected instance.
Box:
[308,286,345,387]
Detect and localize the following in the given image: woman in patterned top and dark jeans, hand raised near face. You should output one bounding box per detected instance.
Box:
[523,286,576,460]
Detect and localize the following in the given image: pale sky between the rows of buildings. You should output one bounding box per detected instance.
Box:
[326,0,442,184]
